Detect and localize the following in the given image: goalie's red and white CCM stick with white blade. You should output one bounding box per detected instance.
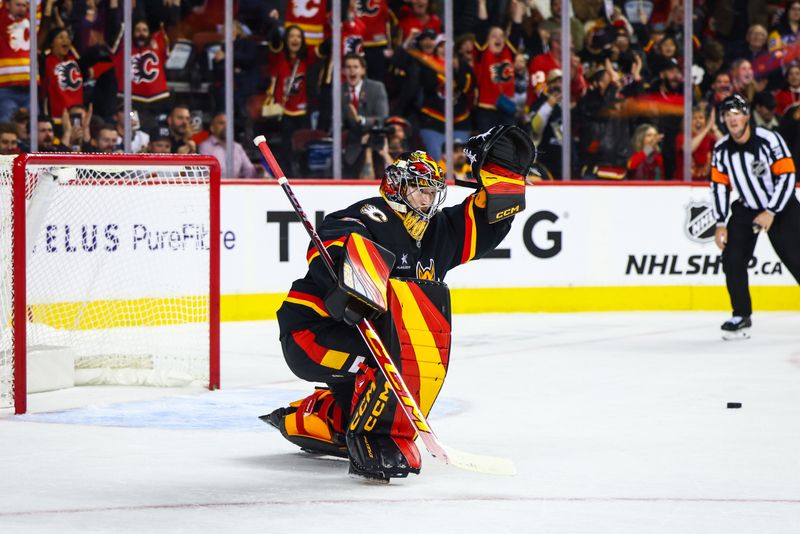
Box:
[253,135,516,475]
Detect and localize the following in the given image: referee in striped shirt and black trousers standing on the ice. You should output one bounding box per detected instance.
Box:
[711,95,800,339]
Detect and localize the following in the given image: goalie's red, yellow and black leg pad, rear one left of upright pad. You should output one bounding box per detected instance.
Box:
[260,388,347,458]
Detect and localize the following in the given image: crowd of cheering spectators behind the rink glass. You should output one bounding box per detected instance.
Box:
[0,0,800,180]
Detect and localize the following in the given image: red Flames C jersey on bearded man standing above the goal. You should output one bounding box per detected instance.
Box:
[112,30,169,102]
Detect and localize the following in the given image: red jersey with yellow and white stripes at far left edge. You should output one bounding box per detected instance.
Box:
[0,2,31,87]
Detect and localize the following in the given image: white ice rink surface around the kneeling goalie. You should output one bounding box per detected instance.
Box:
[0,313,800,534]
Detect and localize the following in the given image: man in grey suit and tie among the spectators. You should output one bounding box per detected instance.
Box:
[342,54,389,178]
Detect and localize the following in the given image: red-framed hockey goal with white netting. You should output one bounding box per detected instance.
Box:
[0,153,220,414]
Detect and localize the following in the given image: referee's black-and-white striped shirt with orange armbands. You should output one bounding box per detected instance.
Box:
[711,128,796,223]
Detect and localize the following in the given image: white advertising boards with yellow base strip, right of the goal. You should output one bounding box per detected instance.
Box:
[222,181,800,318]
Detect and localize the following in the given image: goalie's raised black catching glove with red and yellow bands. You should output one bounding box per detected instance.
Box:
[464,125,536,223]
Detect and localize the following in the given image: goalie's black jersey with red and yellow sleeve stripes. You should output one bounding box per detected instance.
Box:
[278,192,513,337]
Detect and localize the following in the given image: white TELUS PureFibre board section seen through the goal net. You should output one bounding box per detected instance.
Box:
[27,184,211,304]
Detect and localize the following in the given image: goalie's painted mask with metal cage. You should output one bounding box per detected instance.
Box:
[381,150,447,241]
